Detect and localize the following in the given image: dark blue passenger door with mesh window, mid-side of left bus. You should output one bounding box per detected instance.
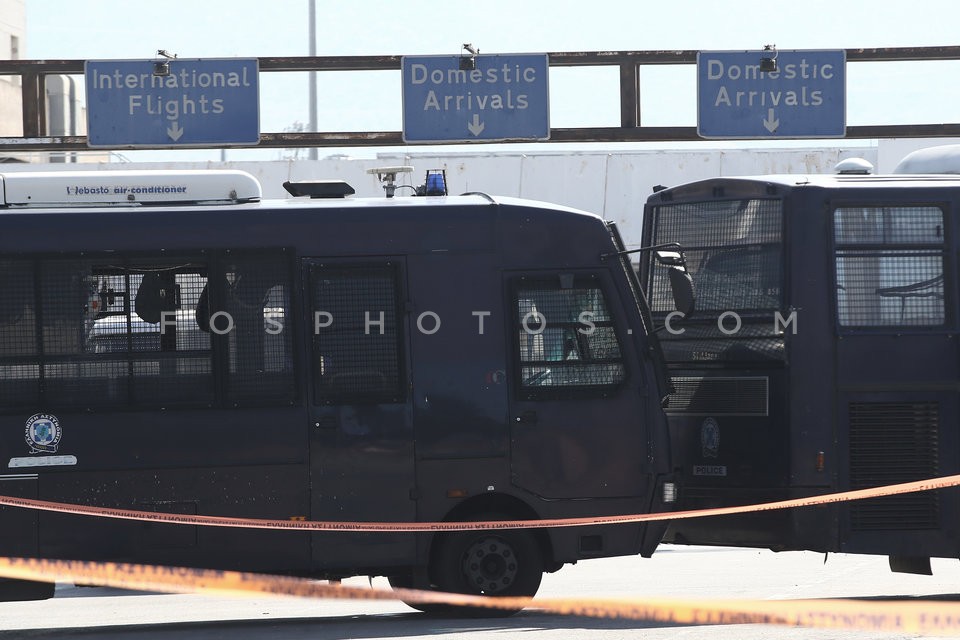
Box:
[303,258,415,568]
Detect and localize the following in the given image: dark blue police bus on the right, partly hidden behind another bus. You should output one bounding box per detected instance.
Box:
[641,149,960,573]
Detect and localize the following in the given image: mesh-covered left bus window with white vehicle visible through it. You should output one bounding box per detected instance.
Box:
[38,255,213,407]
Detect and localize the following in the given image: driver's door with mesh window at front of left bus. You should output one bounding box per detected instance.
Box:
[507,272,650,498]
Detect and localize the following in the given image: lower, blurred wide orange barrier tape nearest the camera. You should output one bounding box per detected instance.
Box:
[0,557,960,635]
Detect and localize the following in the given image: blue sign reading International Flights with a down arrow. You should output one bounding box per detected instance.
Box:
[84,58,260,148]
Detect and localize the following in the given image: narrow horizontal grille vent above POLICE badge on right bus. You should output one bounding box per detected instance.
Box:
[666,376,770,416]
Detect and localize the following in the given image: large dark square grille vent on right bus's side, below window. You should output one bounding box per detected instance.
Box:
[850,402,940,531]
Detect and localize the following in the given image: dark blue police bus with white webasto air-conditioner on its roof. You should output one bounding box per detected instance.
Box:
[0,171,688,612]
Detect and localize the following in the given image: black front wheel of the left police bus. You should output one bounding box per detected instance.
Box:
[430,515,544,617]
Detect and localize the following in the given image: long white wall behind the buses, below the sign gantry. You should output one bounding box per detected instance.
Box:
[0,140,956,247]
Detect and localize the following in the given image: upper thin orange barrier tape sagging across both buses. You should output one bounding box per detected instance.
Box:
[0,475,960,532]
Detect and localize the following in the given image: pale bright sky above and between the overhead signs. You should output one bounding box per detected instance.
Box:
[22,0,960,160]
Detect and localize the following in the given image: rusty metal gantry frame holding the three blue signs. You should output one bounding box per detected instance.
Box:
[0,46,960,155]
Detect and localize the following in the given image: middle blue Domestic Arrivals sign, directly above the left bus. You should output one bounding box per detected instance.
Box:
[402,54,550,142]
